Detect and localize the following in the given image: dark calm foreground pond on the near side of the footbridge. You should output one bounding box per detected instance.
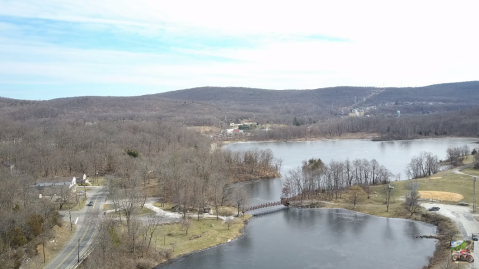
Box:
[159,209,435,269]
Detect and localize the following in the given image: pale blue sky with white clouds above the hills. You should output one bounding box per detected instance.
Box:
[0,0,479,100]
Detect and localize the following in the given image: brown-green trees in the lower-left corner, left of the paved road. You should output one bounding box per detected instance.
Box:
[0,166,62,269]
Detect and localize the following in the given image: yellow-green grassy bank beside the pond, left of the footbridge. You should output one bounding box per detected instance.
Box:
[153,215,251,258]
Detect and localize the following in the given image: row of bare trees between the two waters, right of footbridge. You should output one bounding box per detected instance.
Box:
[282,156,393,201]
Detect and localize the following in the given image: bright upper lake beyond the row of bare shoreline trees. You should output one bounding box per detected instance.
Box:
[224,138,479,179]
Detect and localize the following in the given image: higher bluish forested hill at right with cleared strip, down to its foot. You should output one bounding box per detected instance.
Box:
[151,81,479,118]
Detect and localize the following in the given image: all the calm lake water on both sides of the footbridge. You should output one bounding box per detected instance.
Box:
[158,138,478,269]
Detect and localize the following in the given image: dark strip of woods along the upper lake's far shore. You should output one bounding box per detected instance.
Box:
[250,109,479,140]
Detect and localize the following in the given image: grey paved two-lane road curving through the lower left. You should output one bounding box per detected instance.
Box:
[45,187,107,269]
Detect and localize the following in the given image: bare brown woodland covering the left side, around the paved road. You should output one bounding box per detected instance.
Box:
[0,118,281,268]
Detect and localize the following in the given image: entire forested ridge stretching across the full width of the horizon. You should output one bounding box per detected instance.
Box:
[0,81,479,126]
